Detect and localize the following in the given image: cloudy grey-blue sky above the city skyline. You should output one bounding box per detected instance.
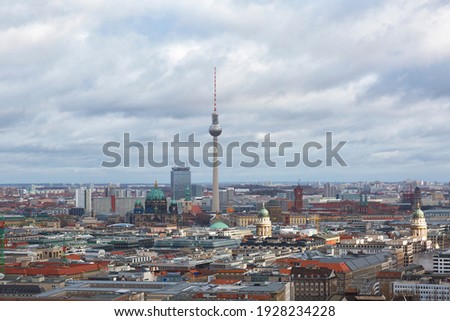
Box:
[0,0,450,183]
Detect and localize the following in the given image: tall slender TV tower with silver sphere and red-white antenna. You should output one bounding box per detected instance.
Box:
[209,67,222,214]
